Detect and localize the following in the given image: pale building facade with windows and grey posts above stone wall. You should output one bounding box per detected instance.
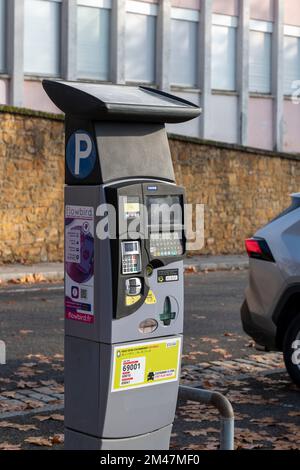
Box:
[0,0,300,153]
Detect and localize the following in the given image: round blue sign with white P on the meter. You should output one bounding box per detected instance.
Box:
[66,130,96,179]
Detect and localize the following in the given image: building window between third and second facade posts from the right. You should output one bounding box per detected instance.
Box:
[212,15,237,91]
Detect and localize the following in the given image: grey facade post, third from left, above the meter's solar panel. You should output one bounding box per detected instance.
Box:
[110,0,126,84]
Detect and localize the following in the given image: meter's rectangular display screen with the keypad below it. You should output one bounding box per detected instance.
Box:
[147,195,184,257]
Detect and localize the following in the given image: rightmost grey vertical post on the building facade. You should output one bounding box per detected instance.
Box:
[272,0,284,152]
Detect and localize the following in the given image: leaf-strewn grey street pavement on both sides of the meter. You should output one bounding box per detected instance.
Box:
[0,271,300,449]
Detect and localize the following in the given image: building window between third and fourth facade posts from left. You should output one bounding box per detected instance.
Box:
[125,1,157,83]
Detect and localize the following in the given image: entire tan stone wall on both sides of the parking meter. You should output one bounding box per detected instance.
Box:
[0,107,300,263]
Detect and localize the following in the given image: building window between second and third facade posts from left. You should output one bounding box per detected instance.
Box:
[77,0,111,80]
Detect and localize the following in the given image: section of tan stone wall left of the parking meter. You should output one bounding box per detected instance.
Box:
[0,110,64,263]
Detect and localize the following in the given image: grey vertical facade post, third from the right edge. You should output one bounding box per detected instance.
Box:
[198,0,212,139]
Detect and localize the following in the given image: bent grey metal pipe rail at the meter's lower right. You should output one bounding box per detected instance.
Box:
[179,385,234,450]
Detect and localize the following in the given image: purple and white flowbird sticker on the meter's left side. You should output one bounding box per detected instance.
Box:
[65,205,94,323]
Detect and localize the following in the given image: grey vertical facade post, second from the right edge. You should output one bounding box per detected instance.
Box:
[237,0,250,145]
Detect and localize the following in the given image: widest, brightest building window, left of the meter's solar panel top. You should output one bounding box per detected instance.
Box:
[24,0,61,76]
